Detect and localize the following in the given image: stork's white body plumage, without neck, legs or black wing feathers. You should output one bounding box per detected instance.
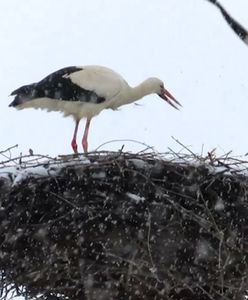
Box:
[13,65,132,120]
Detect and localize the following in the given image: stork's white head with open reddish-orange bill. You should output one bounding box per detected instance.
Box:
[148,77,182,109]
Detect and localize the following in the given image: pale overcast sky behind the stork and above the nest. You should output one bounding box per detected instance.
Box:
[0,0,248,156]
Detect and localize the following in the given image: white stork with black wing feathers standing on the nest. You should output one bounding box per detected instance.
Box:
[9,66,181,153]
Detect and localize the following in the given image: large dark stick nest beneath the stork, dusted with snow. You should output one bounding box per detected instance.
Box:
[0,148,248,300]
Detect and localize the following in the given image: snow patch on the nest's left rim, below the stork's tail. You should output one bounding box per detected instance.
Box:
[0,155,90,186]
